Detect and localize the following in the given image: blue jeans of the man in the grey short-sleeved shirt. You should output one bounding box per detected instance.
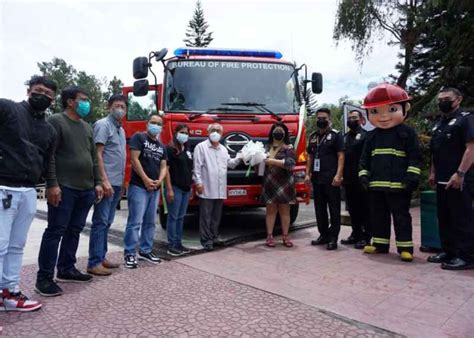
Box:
[87,186,122,268]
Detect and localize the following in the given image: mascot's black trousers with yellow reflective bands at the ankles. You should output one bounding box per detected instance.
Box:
[369,190,413,253]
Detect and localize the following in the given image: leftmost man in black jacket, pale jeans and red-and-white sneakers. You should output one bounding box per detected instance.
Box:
[0,76,57,311]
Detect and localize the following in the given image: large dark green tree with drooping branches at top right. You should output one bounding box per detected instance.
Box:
[334,0,474,115]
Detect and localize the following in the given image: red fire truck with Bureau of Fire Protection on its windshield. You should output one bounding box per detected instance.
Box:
[123,48,322,227]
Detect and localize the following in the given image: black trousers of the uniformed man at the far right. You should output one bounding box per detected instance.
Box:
[436,184,474,261]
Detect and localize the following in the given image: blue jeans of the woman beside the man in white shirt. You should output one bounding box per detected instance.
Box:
[166,186,191,249]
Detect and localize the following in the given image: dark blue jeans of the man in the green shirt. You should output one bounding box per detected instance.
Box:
[38,187,95,279]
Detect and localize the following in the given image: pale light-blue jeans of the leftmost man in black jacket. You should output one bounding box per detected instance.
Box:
[0,188,36,290]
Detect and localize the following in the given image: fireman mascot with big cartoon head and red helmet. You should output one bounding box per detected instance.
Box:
[359,83,421,262]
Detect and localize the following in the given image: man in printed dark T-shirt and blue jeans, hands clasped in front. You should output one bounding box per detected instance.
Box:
[124,115,167,269]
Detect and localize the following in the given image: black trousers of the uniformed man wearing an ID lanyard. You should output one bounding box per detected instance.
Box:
[313,182,341,241]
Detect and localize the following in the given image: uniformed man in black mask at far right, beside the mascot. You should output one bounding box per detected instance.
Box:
[428,88,474,270]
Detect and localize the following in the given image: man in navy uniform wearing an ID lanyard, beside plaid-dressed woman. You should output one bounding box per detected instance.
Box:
[305,108,344,250]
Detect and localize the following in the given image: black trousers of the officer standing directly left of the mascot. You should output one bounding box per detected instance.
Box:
[344,182,372,240]
